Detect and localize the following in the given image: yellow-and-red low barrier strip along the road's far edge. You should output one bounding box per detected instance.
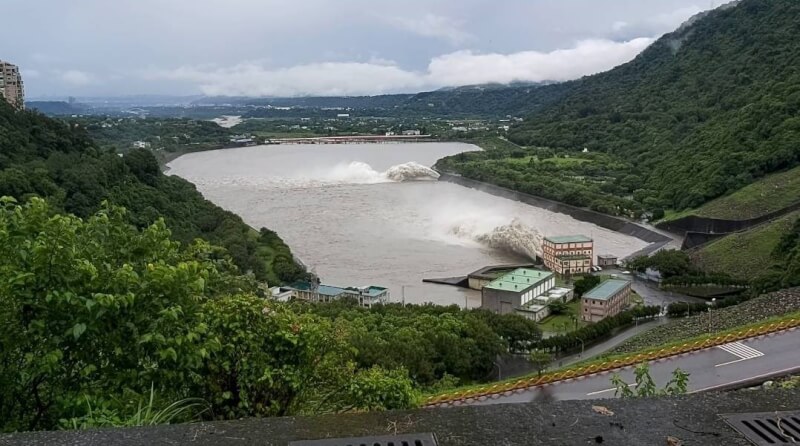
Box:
[422,318,800,407]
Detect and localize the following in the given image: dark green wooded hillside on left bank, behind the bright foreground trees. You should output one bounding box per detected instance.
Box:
[0,102,305,283]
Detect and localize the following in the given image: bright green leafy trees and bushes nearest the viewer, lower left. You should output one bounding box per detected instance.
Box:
[0,198,415,431]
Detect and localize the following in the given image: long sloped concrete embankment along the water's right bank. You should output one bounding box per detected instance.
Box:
[439,172,673,247]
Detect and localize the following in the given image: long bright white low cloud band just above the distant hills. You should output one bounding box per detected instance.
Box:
[142,38,653,96]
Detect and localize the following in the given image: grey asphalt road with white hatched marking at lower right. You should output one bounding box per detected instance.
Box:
[464,329,800,405]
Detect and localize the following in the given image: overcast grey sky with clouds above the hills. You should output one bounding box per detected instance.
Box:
[0,0,720,97]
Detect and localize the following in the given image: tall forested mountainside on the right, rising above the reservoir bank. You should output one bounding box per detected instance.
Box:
[450,0,800,214]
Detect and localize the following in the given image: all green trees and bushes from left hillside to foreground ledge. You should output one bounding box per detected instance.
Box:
[0,100,556,431]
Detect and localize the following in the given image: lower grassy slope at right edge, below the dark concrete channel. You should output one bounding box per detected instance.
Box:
[690,211,800,277]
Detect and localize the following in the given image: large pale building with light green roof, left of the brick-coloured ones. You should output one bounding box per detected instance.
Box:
[481,268,572,321]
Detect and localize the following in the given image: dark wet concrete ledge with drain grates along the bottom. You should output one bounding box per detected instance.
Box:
[0,389,800,446]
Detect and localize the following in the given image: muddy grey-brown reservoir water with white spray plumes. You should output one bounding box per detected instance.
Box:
[169,143,646,307]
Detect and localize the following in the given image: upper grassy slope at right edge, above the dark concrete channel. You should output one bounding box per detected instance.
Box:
[661,167,800,221]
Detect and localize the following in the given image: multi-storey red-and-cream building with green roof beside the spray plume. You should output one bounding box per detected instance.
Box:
[542,235,594,275]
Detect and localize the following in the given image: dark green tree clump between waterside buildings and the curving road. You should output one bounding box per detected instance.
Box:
[296,301,541,388]
